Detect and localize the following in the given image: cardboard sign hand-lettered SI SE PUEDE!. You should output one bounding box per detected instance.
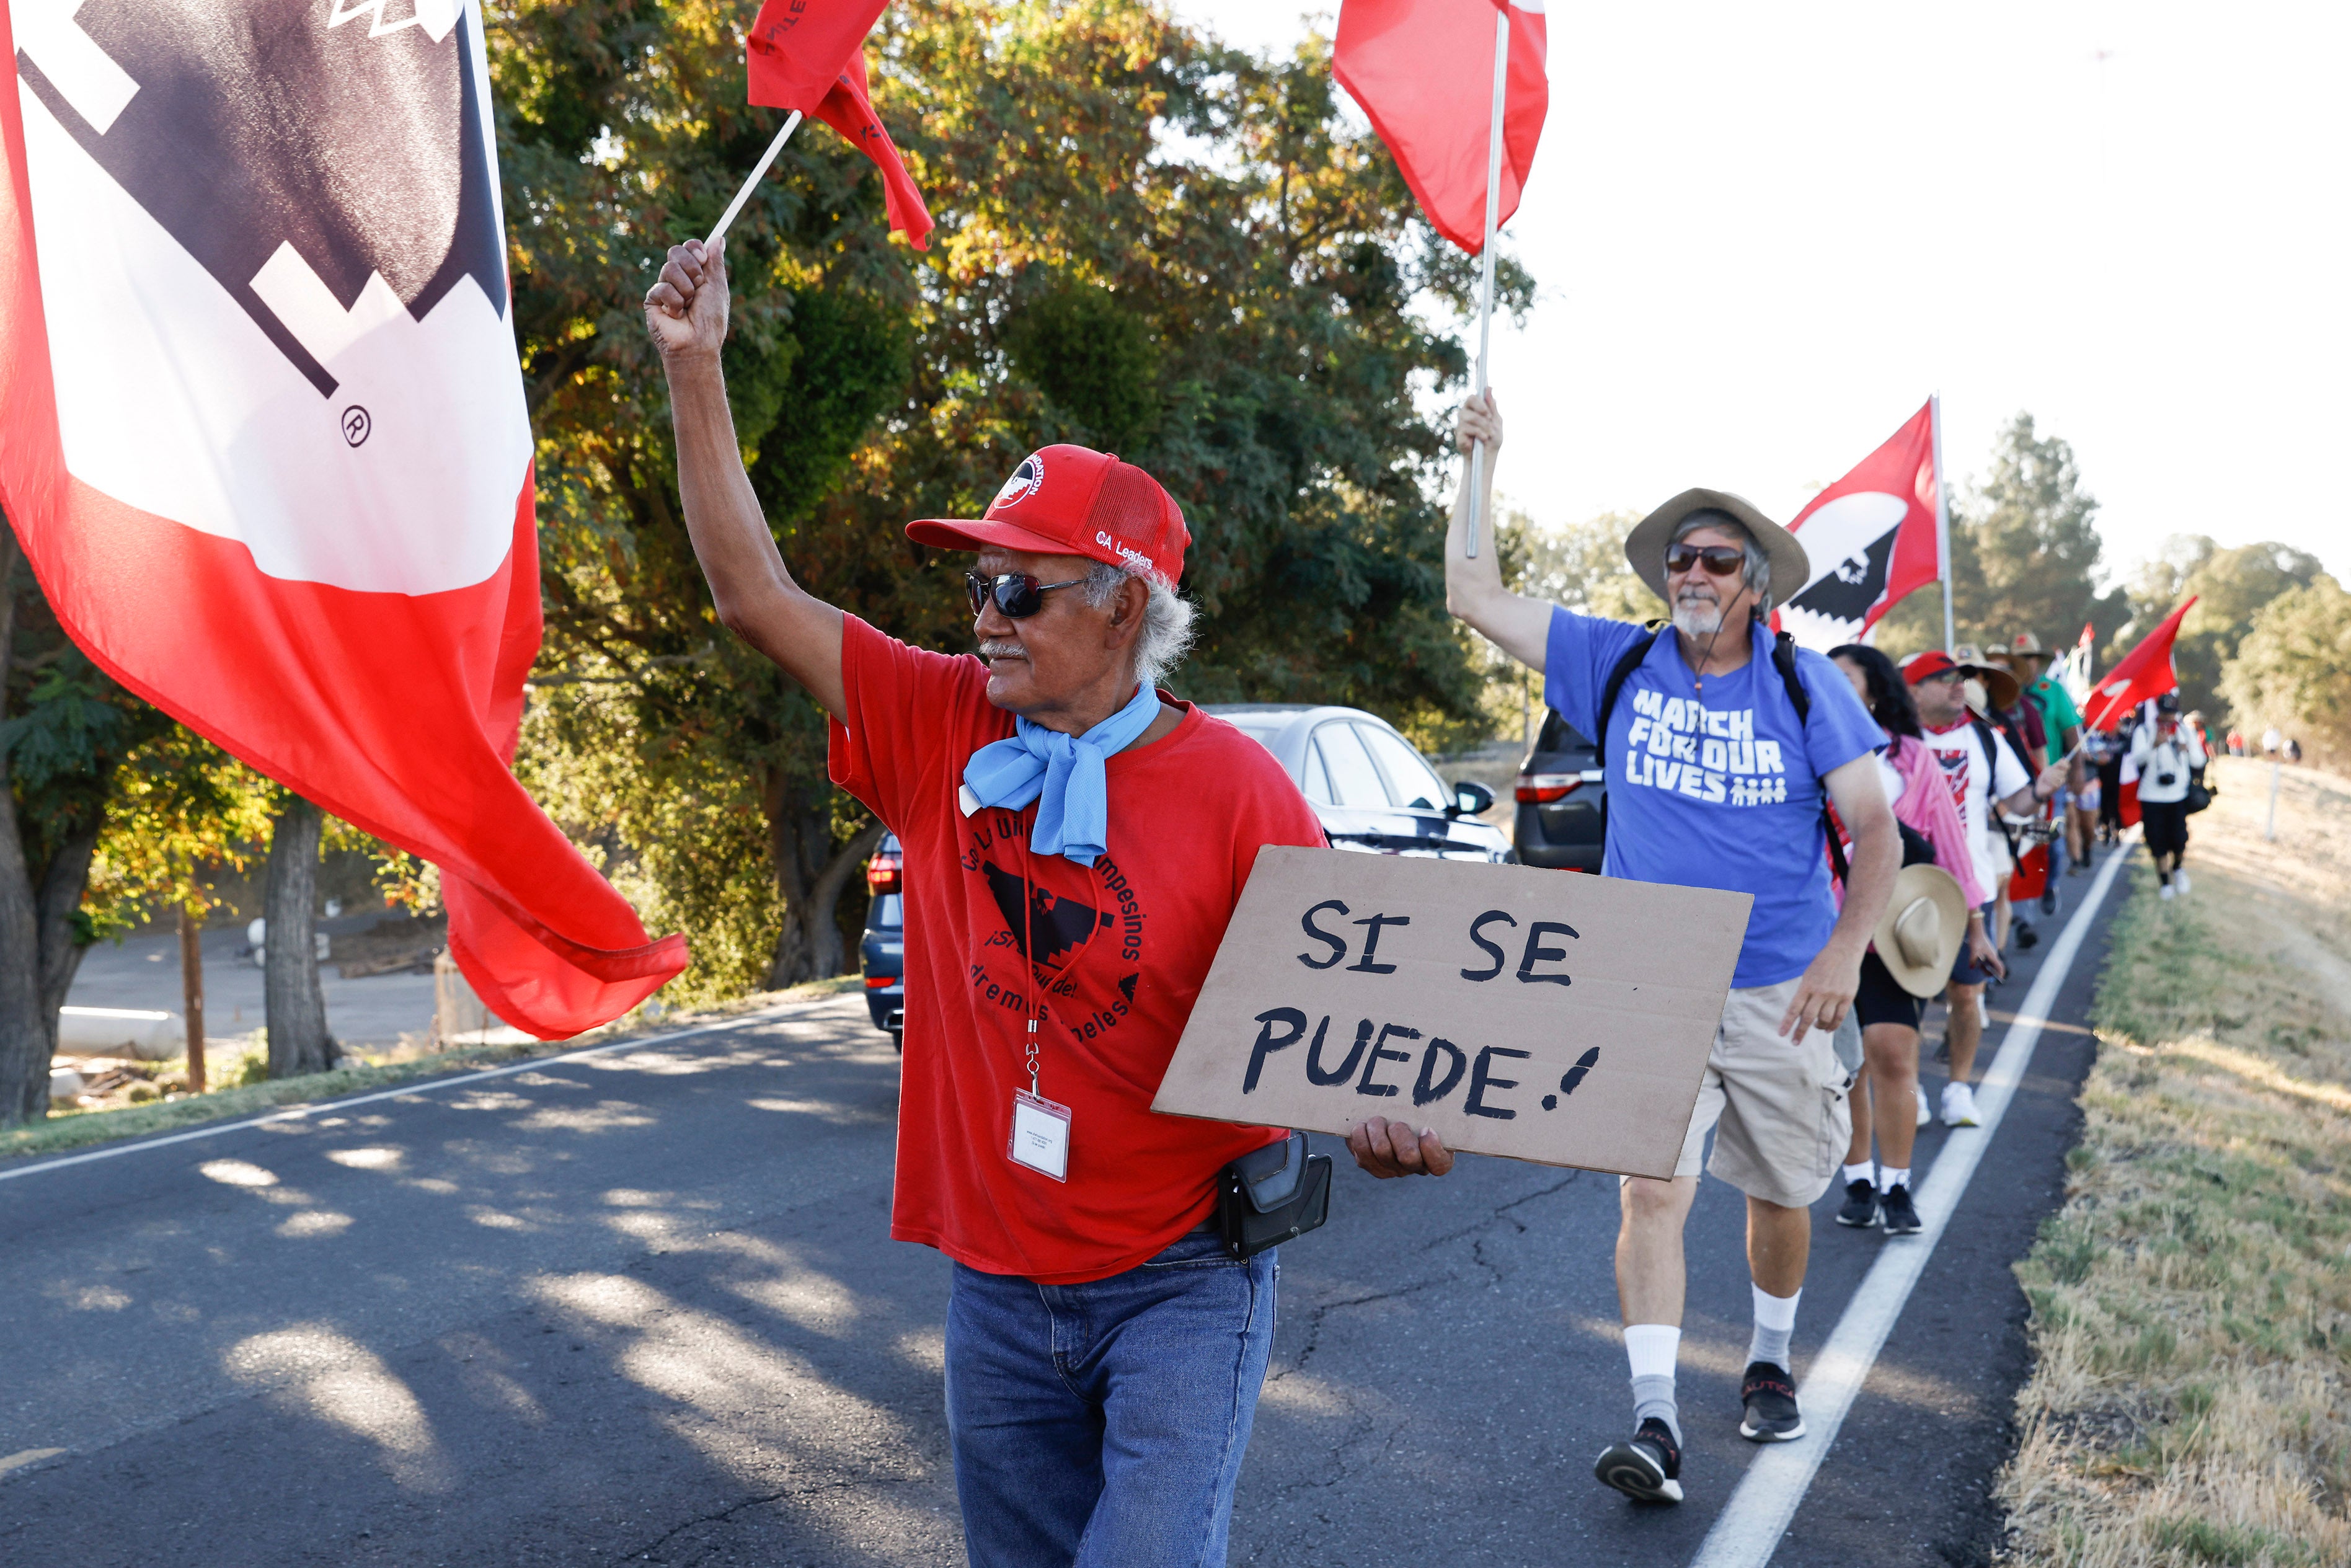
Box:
[1152,844,1754,1176]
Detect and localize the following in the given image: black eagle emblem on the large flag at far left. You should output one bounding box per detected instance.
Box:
[14,0,505,397]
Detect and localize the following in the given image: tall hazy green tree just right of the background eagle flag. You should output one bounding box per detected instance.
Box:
[1879,414,2130,656]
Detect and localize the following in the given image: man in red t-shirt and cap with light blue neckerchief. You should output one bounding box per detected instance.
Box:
[644,242,1391,1568]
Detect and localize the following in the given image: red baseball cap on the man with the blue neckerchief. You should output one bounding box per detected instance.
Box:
[905,446,1192,588]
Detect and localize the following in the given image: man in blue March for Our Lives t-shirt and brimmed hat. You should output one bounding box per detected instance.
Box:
[1366,397,1902,1502]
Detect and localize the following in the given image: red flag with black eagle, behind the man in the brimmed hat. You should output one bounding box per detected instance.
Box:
[1773,400,1942,653]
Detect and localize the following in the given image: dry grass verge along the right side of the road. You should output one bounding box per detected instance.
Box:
[1998,760,2351,1568]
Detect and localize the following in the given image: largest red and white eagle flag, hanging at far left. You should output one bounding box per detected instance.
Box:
[0,0,686,1039]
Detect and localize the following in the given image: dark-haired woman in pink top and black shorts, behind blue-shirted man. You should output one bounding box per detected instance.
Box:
[1829,642,1991,1236]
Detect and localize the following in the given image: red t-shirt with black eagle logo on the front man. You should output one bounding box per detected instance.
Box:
[830,616,1324,1283]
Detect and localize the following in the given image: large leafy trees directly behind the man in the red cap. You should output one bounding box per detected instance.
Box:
[505,0,1531,994]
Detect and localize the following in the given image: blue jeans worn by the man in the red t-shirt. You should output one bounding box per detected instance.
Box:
[947,1232,1277,1568]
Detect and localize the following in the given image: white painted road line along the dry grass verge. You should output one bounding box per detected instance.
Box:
[1690,851,2130,1568]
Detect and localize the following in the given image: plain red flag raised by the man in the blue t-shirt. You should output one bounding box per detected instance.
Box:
[1330,0,1552,256]
